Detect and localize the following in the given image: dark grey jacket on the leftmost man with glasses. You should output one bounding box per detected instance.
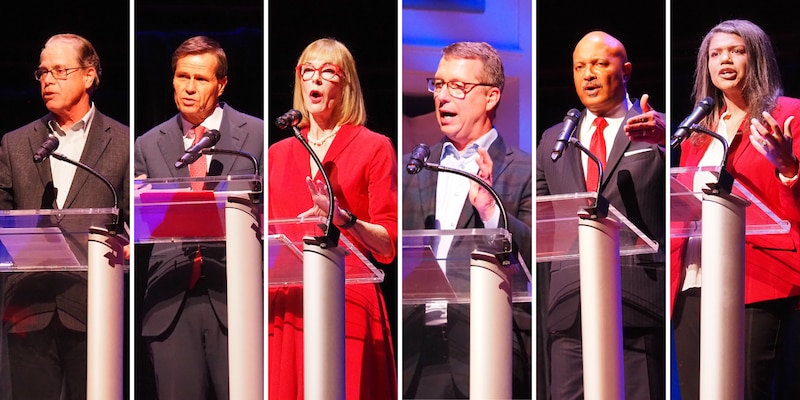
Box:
[0,111,130,331]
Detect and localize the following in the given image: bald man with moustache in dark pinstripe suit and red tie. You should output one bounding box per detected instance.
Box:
[536,32,666,399]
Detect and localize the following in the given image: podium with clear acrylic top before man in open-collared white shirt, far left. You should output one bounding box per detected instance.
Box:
[0,208,128,400]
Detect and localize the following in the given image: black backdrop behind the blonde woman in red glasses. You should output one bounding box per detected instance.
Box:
[266,0,399,370]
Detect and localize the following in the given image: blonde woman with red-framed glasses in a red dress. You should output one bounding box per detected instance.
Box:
[268,39,397,400]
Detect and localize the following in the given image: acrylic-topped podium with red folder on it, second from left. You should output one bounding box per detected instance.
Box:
[133,175,264,400]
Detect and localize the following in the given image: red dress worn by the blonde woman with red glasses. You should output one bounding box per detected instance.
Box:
[267,125,397,399]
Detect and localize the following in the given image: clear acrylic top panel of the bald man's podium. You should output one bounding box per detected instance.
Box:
[536,192,658,262]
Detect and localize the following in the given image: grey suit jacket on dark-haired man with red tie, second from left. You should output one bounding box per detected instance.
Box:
[134,103,264,336]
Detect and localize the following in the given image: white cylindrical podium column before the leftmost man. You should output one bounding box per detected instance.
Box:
[86,227,125,400]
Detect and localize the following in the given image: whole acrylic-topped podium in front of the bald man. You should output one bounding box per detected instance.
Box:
[536,192,658,399]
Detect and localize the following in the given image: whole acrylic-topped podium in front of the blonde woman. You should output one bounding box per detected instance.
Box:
[267,217,384,400]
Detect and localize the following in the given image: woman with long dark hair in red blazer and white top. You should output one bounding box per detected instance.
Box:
[671,20,800,400]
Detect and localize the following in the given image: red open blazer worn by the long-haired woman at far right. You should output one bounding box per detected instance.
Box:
[670,97,800,312]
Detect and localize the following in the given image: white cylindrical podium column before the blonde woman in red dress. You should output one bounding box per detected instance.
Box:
[303,243,345,400]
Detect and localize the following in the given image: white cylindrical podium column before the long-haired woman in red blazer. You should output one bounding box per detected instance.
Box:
[700,195,749,400]
